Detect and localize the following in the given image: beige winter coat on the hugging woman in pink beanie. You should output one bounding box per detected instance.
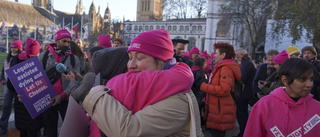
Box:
[83,86,204,137]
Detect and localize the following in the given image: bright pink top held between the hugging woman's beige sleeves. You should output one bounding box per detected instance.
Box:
[106,63,194,114]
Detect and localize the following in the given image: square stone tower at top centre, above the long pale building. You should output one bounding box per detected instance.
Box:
[136,0,164,21]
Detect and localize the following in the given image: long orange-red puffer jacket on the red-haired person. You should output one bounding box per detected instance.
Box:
[200,62,241,131]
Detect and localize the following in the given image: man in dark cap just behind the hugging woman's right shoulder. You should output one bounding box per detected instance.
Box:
[172,39,193,68]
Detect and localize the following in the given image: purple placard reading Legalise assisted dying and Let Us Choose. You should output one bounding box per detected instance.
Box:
[6,57,57,118]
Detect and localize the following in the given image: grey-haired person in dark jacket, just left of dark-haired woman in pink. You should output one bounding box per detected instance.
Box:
[253,49,279,104]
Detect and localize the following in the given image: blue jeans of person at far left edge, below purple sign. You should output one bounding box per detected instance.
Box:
[0,85,17,129]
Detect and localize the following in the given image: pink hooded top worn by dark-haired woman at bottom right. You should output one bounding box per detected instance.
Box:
[244,87,320,137]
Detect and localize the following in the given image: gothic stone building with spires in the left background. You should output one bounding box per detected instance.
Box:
[0,0,122,47]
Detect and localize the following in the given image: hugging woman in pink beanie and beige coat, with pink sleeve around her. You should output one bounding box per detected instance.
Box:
[83,29,203,137]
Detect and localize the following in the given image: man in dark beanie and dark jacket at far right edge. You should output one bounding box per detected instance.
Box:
[301,46,320,101]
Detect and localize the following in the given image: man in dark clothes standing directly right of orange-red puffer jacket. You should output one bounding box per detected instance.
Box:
[236,48,256,137]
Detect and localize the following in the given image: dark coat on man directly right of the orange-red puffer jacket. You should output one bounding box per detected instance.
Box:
[240,57,256,99]
